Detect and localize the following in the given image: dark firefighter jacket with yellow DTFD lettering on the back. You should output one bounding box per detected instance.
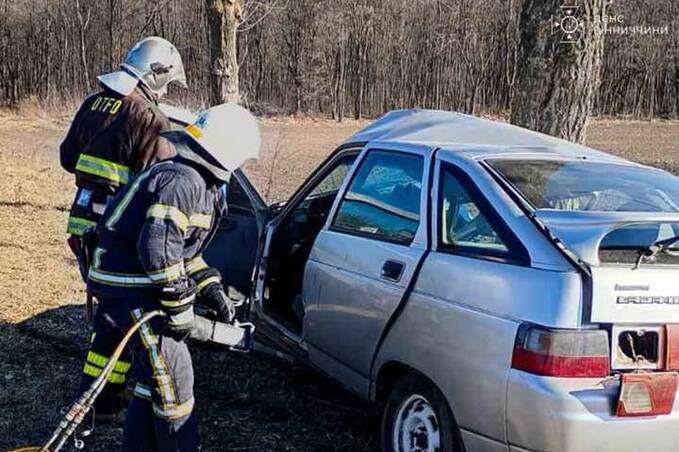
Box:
[60,85,174,235]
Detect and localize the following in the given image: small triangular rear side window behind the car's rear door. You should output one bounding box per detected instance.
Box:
[438,164,529,263]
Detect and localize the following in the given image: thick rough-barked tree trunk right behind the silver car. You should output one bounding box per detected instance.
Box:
[511,0,605,142]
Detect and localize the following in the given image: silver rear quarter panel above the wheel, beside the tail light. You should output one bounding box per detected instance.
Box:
[373,252,581,450]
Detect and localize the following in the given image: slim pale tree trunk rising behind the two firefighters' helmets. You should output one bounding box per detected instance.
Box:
[205,0,241,105]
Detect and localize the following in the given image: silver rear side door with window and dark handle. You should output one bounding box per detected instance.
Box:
[303,145,429,394]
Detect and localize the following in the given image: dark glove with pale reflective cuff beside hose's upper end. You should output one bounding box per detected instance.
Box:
[159,278,196,340]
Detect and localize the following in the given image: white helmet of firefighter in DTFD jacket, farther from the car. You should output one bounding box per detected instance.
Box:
[97,36,187,96]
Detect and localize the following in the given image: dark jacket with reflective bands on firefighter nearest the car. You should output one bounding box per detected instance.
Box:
[87,144,226,298]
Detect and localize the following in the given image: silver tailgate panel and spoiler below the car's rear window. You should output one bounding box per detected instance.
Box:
[536,210,679,324]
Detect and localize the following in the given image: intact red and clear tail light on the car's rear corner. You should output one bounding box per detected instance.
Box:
[512,325,610,377]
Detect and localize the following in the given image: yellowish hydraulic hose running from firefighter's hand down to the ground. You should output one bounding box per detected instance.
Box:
[9,310,166,452]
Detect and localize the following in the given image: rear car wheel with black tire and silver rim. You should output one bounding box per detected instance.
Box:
[380,375,464,452]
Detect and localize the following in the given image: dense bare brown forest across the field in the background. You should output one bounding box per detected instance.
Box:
[0,0,679,119]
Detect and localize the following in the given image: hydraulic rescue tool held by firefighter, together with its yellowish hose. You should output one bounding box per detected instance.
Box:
[9,310,255,452]
